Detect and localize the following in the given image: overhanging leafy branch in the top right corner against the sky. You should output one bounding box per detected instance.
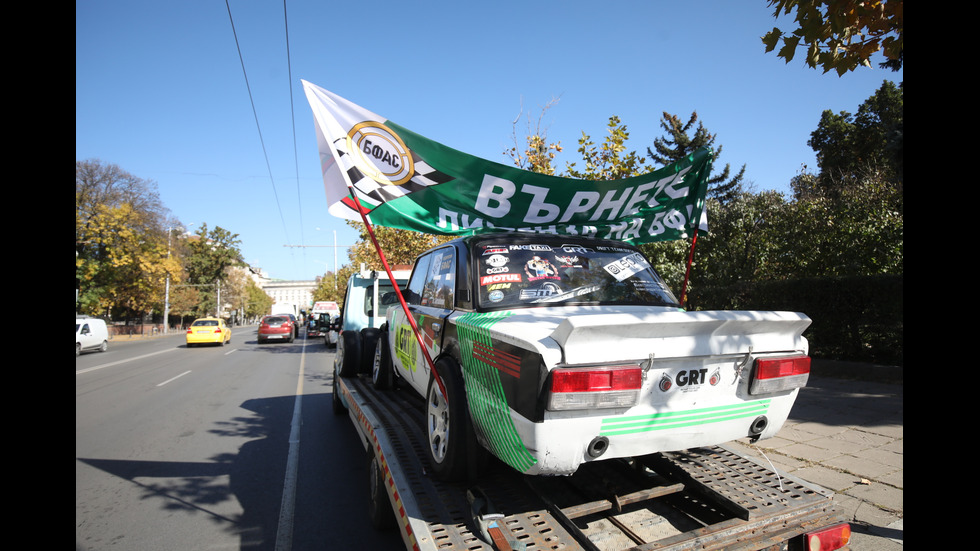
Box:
[762,0,904,76]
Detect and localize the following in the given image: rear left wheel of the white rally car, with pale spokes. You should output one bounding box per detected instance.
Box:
[425,358,476,481]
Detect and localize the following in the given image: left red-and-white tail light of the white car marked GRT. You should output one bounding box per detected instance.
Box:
[548,365,643,411]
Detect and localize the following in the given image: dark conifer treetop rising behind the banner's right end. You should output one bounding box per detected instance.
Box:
[647,111,745,204]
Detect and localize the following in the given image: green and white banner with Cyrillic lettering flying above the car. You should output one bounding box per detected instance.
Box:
[303,80,712,244]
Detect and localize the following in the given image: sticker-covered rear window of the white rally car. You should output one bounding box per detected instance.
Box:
[474,243,677,309]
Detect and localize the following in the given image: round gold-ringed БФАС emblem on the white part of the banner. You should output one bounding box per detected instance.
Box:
[347,121,415,186]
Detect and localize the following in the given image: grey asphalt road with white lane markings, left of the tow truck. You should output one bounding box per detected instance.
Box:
[75,327,403,551]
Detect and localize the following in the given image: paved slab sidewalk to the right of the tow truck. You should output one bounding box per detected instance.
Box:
[731,360,905,551]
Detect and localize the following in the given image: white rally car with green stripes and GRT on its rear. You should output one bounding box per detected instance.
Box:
[372,233,810,479]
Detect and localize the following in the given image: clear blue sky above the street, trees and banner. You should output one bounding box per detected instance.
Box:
[75,0,904,279]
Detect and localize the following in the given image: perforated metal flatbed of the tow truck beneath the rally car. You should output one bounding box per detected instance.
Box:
[334,373,850,551]
